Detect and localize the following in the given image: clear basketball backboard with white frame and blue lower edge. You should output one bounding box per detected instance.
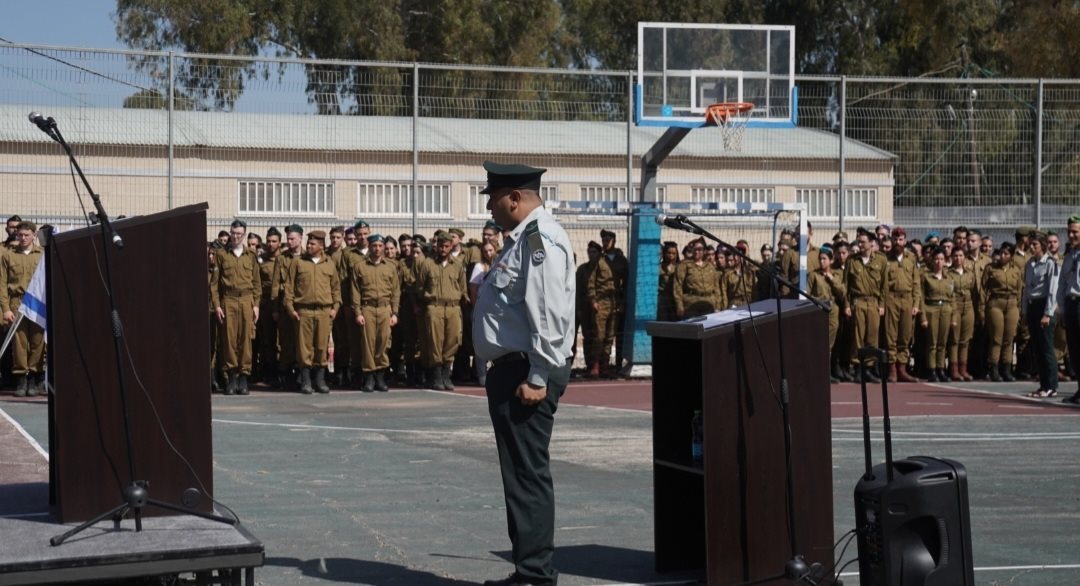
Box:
[634,23,798,127]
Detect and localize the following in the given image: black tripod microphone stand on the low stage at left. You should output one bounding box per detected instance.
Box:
[31,118,237,546]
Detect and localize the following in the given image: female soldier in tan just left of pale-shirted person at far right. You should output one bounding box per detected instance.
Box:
[980,242,1023,382]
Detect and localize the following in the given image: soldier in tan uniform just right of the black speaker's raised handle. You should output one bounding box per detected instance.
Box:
[885,228,922,382]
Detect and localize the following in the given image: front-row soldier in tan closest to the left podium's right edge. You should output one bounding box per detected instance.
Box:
[210,220,262,395]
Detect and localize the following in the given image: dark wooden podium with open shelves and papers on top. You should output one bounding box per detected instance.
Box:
[646,300,833,585]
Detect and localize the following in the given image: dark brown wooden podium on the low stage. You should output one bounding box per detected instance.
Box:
[46,204,214,522]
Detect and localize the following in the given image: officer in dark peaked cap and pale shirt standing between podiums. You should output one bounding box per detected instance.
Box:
[473,162,576,586]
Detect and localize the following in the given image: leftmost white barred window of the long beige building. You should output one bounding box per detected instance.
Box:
[237,180,335,216]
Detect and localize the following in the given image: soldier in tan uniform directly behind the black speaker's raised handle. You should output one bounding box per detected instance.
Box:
[843,232,889,383]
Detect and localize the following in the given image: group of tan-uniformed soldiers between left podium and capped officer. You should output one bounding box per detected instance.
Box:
[208,220,500,394]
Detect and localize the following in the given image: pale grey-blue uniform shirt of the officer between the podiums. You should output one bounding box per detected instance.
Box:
[473,207,577,386]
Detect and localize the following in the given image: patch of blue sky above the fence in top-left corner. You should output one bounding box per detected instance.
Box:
[0,0,123,49]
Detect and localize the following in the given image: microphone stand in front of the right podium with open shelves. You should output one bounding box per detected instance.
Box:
[677,216,829,586]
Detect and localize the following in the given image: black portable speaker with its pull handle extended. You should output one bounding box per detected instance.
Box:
[855,347,975,586]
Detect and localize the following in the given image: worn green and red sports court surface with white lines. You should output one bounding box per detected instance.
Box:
[0,375,1080,585]
